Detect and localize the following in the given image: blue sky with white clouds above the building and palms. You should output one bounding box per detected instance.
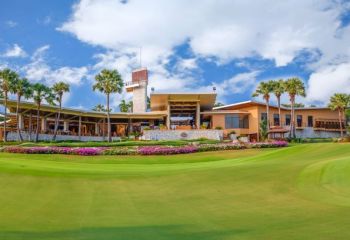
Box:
[0,0,350,111]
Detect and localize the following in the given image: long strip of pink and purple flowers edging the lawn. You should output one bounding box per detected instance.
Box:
[2,141,288,156]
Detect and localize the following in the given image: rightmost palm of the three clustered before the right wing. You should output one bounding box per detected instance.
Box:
[284,77,306,138]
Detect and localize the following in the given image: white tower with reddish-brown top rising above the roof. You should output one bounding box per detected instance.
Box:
[125,68,148,113]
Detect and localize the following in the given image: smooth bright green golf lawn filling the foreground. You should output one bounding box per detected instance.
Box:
[0,143,350,240]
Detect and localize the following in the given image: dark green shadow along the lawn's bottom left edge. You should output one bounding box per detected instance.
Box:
[0,225,249,240]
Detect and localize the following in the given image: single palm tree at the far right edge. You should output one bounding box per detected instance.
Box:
[329,93,350,138]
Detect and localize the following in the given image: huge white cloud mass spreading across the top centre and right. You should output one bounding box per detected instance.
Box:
[58,0,350,102]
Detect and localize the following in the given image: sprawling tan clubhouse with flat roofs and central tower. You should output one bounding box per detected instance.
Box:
[0,69,345,141]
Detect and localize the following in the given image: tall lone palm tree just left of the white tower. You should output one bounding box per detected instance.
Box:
[92,69,124,142]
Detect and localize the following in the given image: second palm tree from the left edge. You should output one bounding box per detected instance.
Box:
[10,78,33,142]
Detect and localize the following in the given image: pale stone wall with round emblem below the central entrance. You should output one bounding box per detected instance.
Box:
[143,130,224,140]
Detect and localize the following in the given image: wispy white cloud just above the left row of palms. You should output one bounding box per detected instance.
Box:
[22,45,88,85]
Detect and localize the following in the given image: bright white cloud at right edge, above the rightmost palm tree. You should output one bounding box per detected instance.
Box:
[307,62,350,103]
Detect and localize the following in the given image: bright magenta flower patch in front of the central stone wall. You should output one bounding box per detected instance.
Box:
[137,146,198,155]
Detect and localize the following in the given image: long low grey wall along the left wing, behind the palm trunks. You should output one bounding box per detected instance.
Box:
[7,132,120,142]
